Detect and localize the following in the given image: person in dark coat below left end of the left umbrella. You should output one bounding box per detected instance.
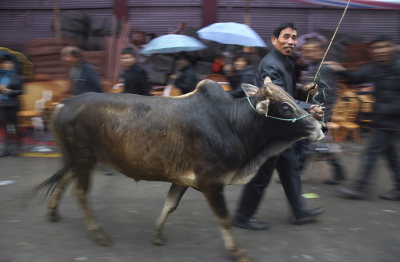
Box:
[120,48,150,96]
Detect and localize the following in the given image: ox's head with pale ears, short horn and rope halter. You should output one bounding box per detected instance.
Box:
[242,77,324,141]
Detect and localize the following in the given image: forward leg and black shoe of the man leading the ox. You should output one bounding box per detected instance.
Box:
[276,147,325,224]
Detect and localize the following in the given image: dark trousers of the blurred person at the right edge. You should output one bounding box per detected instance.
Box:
[357,129,400,190]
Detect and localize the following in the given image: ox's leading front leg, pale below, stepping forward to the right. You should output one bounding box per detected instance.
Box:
[201,185,250,262]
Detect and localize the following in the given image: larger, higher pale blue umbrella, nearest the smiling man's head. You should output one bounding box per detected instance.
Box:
[197,22,267,47]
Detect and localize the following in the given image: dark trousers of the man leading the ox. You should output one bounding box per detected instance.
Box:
[236,147,303,218]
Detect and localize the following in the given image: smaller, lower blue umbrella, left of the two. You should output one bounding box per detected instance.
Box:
[140,34,206,55]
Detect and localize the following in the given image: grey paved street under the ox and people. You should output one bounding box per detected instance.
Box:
[0,133,400,262]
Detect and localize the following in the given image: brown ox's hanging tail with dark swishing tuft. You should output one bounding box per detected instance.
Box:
[34,104,69,197]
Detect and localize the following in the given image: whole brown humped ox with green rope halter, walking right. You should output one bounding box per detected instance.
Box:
[39,80,323,261]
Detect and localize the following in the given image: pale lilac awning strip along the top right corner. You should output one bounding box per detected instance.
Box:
[293,0,400,9]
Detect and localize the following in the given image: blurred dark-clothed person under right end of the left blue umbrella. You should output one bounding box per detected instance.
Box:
[170,53,197,94]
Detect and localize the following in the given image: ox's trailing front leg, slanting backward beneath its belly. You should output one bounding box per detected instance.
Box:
[153,184,187,245]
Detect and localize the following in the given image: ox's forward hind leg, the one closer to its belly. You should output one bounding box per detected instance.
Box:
[72,163,112,246]
